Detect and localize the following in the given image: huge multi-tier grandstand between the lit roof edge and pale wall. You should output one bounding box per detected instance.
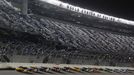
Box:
[0,0,134,67]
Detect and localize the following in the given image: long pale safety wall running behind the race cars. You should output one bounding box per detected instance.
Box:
[0,63,134,70]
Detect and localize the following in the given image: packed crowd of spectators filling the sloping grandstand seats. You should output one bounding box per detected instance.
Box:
[0,0,134,64]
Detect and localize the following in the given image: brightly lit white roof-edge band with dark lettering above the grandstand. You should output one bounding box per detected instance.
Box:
[41,0,134,25]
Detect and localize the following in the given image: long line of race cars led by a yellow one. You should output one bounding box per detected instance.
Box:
[15,66,134,74]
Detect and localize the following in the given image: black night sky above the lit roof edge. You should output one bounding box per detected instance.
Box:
[61,0,134,20]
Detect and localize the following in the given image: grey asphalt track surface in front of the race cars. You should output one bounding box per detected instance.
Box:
[0,71,134,75]
